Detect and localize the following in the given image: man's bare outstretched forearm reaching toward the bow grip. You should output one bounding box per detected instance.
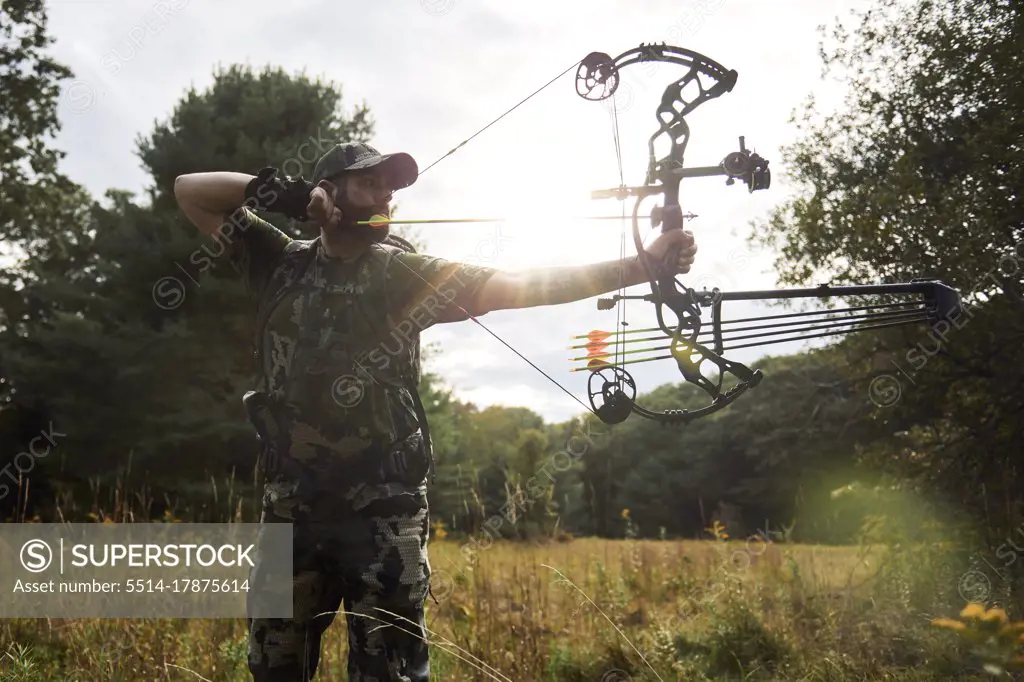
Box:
[487,257,647,310]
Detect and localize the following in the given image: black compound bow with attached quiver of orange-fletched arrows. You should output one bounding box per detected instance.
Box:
[411,43,959,425]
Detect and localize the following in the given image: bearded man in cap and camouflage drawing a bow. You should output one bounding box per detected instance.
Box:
[174,142,696,682]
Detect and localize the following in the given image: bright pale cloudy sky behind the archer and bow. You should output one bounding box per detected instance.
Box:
[41,0,863,420]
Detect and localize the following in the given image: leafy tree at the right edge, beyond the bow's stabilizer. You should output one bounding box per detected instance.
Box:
[758,0,1024,544]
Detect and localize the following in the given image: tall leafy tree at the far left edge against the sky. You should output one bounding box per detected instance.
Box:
[0,0,92,505]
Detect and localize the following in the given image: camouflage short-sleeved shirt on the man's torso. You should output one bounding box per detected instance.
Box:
[230,209,495,489]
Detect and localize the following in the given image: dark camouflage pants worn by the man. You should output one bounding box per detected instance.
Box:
[249,483,430,682]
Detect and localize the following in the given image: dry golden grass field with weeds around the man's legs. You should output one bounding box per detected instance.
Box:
[0,539,1005,682]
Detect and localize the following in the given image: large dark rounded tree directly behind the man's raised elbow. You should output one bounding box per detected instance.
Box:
[0,62,380,516]
